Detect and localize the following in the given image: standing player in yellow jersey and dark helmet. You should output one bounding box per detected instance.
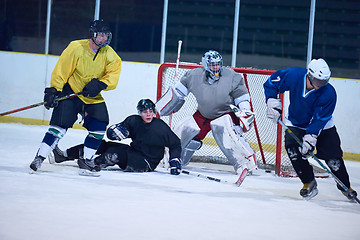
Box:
[30,20,121,176]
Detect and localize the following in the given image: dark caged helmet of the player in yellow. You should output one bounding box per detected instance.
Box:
[89,20,112,48]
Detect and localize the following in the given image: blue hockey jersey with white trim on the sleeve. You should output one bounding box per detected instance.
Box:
[263,67,336,135]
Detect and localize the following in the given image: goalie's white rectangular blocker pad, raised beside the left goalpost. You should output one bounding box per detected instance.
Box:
[155,87,185,116]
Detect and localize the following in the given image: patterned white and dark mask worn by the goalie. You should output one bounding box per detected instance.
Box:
[201,50,223,80]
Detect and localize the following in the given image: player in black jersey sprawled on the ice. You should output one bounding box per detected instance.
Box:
[49,99,181,175]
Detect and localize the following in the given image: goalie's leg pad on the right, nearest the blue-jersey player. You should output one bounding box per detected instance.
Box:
[210,114,257,172]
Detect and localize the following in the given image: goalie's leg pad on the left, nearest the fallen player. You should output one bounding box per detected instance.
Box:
[174,116,202,166]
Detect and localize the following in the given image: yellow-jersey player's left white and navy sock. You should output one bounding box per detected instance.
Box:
[37,126,66,158]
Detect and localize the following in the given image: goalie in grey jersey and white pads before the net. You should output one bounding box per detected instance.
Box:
[156,50,257,176]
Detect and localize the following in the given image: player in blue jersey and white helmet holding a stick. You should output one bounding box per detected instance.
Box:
[264,58,357,199]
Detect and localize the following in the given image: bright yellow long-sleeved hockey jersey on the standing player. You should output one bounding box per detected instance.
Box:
[51,39,121,104]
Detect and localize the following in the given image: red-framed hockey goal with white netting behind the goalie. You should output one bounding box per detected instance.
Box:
[157,63,326,177]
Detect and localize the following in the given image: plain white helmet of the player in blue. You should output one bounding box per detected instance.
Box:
[307,58,331,87]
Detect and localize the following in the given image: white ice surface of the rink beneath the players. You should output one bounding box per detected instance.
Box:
[0,123,360,240]
